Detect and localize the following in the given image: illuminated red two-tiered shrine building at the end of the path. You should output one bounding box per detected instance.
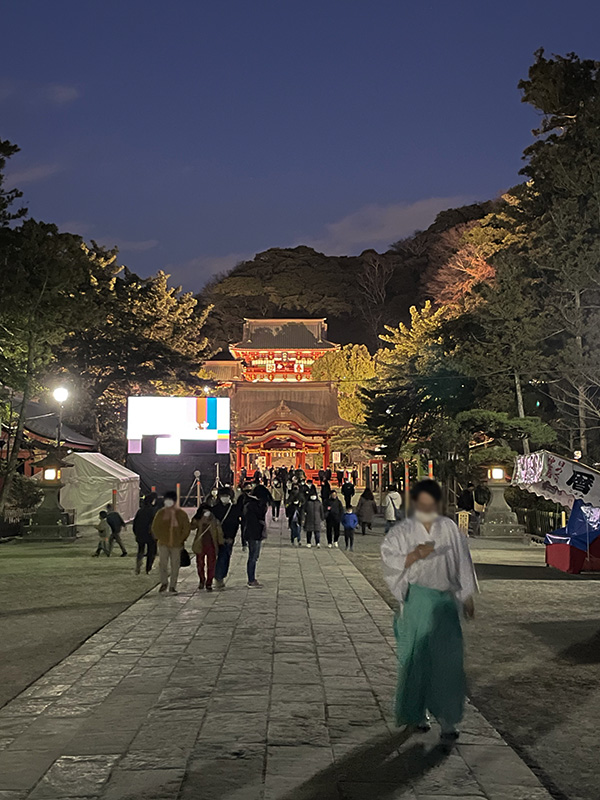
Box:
[205,319,349,480]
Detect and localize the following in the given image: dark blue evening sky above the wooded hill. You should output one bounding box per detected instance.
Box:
[0,0,600,290]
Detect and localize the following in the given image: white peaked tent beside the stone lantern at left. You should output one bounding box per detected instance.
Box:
[60,453,140,525]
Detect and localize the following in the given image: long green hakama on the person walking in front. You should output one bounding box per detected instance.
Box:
[394,584,466,727]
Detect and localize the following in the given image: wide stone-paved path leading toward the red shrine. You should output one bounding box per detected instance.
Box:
[0,524,550,800]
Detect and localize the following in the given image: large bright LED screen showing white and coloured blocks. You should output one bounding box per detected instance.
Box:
[127,397,231,455]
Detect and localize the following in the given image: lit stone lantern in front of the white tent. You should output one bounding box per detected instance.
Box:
[24,453,77,542]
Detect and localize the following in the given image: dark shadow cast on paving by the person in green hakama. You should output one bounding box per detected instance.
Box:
[281,732,447,800]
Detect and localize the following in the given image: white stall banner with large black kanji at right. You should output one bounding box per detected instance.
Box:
[512,450,600,508]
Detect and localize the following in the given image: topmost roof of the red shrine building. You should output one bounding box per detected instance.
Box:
[231,318,338,350]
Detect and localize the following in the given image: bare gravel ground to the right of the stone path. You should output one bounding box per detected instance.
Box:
[348,525,600,800]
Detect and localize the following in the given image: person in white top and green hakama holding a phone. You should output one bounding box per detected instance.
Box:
[381,479,477,749]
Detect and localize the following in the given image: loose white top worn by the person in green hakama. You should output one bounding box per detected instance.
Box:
[381,517,477,604]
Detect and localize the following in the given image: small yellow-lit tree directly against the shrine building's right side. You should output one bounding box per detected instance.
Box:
[312,344,377,425]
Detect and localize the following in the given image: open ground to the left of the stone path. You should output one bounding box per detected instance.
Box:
[0,529,157,706]
